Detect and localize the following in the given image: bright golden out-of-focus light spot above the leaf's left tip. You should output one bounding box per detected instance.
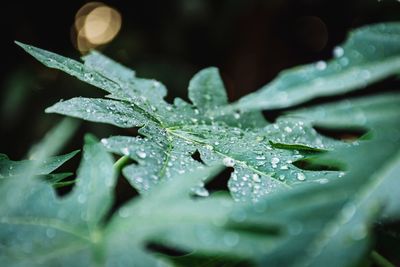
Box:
[72,2,122,54]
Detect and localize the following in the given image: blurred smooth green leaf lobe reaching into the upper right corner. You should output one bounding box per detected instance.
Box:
[228,22,400,111]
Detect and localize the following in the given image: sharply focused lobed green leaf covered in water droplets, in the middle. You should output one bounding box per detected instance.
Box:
[20,44,344,201]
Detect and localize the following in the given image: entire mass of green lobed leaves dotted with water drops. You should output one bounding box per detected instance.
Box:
[0,23,400,266]
